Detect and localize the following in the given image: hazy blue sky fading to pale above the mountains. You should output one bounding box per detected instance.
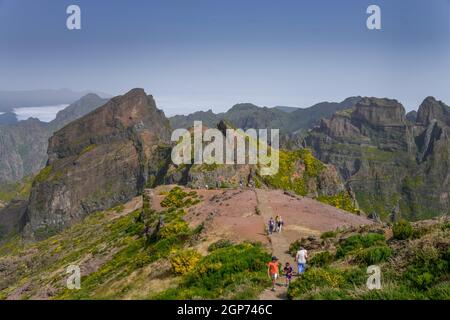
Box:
[0,0,450,114]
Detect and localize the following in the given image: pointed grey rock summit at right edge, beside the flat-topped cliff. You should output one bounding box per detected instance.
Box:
[416,97,450,126]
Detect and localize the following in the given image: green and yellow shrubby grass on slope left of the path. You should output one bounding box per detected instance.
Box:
[0,187,269,299]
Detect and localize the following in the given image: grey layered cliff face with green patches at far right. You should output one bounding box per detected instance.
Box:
[306,97,450,219]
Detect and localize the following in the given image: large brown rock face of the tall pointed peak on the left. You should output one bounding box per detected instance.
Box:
[26,89,170,237]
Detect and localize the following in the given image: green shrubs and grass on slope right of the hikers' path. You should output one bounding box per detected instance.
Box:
[288,219,450,300]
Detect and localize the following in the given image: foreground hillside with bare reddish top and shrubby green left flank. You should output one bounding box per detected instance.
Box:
[0,186,372,299]
